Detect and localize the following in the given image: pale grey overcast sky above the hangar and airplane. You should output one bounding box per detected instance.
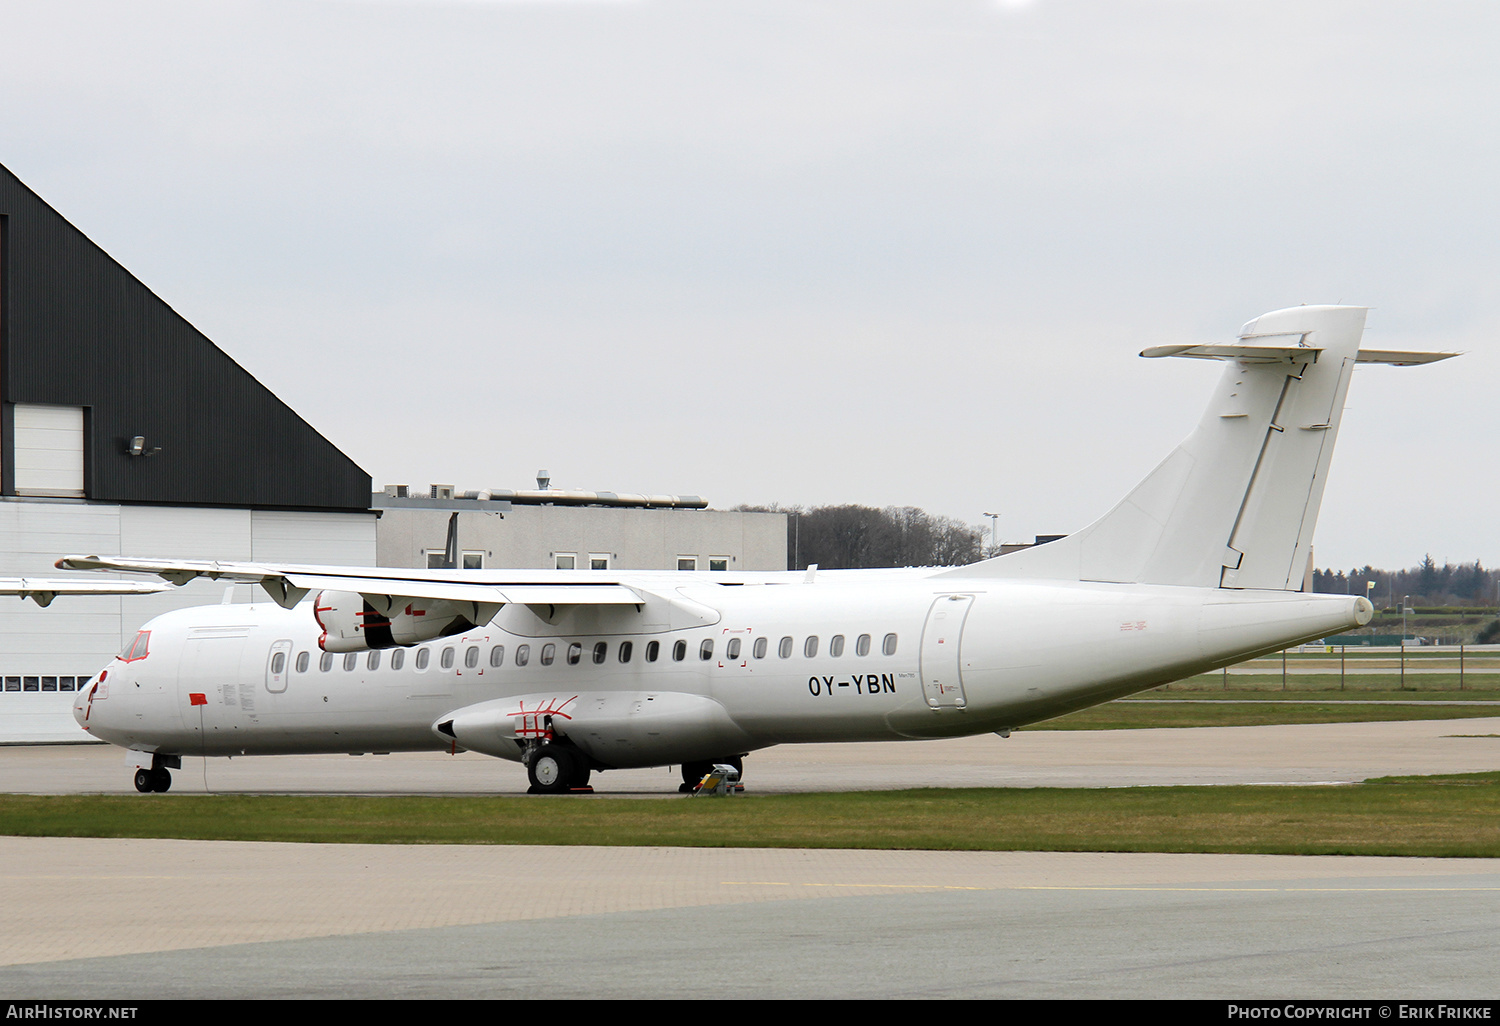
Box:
[0,0,1500,569]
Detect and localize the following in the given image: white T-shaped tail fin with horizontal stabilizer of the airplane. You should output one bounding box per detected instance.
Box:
[945,306,1455,591]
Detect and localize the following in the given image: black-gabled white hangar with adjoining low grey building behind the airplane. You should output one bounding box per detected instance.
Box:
[0,167,786,743]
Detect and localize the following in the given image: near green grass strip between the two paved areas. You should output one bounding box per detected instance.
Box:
[0,774,1500,858]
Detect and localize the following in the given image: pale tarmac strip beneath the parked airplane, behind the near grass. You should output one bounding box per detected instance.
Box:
[0,717,1500,797]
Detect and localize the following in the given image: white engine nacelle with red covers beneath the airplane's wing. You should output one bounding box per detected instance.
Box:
[312,591,500,653]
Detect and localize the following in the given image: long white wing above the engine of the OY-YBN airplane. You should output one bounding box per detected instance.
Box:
[55,555,645,609]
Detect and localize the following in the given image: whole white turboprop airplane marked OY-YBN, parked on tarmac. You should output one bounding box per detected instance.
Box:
[57,306,1454,792]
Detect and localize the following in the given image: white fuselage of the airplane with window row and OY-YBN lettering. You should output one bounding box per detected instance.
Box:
[75,570,1370,770]
